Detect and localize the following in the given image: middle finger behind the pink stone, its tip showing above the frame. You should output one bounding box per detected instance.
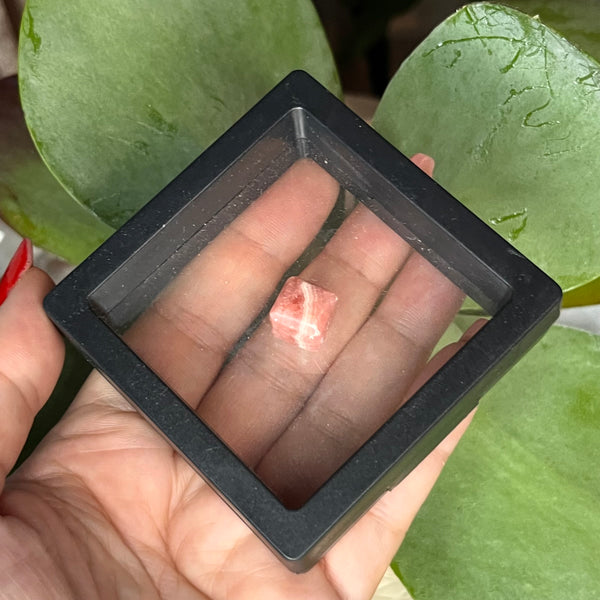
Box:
[198,155,433,465]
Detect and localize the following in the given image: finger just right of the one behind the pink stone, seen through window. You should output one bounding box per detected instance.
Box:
[257,248,464,507]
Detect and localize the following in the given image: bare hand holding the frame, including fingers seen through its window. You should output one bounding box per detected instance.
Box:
[0,155,473,600]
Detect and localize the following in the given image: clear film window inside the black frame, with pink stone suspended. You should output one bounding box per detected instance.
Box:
[91,159,489,508]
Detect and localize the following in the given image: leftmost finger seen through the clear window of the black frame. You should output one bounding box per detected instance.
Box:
[119,160,339,405]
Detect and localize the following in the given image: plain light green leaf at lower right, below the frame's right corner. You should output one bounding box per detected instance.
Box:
[393,327,600,600]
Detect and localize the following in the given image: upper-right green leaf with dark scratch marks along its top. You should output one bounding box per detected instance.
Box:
[374,4,600,298]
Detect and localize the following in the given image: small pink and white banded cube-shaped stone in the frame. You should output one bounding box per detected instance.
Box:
[269,277,337,351]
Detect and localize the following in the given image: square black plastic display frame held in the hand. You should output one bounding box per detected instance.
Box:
[45,71,561,572]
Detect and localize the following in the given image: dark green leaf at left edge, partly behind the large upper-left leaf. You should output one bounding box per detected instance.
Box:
[0,77,112,263]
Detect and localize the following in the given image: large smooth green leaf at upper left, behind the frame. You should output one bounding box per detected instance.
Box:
[19,0,340,227]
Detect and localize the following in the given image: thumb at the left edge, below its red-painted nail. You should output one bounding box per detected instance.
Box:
[0,268,64,489]
